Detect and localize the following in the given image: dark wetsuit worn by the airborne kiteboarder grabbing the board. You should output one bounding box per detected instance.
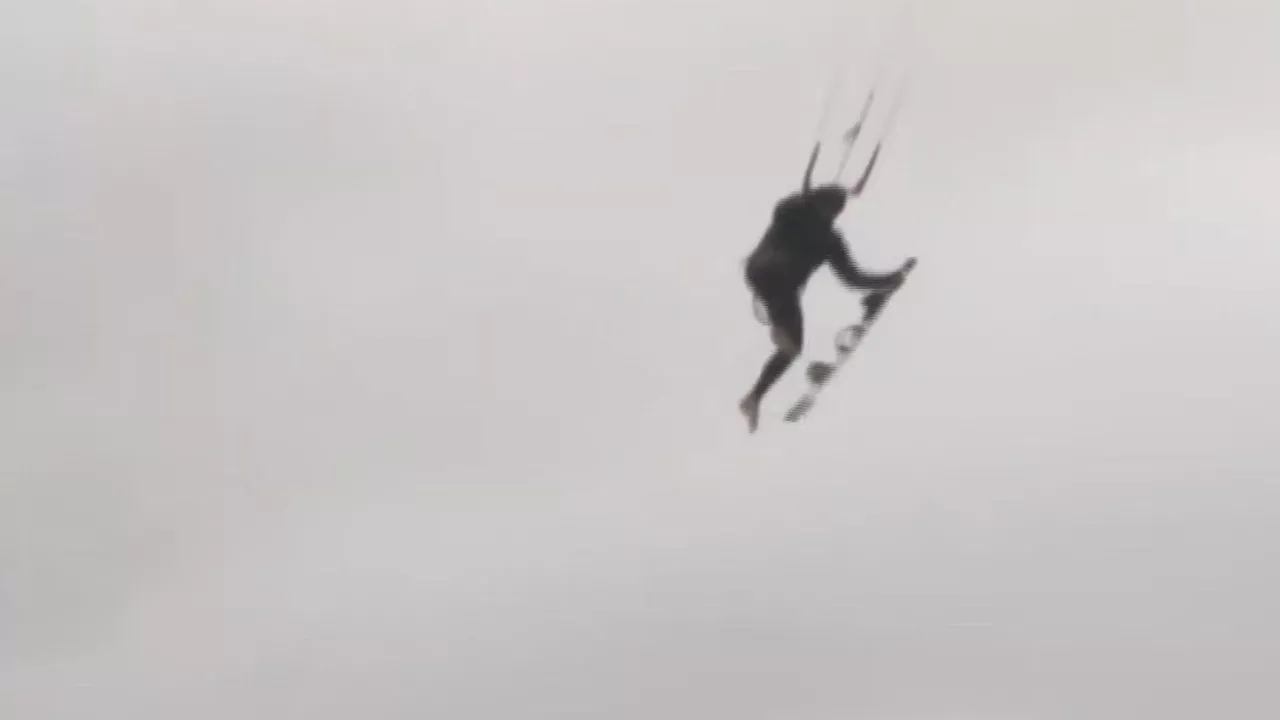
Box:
[745,188,900,397]
